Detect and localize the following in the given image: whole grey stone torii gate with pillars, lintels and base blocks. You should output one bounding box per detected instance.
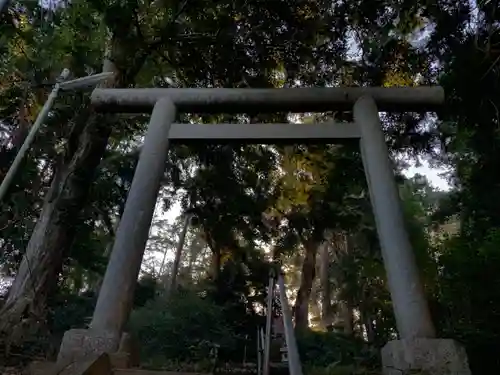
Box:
[58,87,470,375]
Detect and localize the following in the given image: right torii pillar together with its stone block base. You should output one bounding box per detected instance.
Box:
[354,96,470,375]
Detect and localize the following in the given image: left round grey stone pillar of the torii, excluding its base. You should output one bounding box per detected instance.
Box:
[90,98,176,332]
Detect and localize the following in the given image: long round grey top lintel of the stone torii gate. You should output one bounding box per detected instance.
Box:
[91,86,444,113]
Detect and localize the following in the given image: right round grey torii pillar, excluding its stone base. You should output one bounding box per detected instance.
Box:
[353,96,436,339]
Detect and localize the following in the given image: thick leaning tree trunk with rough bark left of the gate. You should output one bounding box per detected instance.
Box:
[0,27,147,332]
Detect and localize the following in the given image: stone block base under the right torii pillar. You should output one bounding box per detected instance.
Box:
[382,339,471,375]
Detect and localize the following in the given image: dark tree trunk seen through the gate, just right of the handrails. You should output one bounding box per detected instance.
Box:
[294,241,318,331]
